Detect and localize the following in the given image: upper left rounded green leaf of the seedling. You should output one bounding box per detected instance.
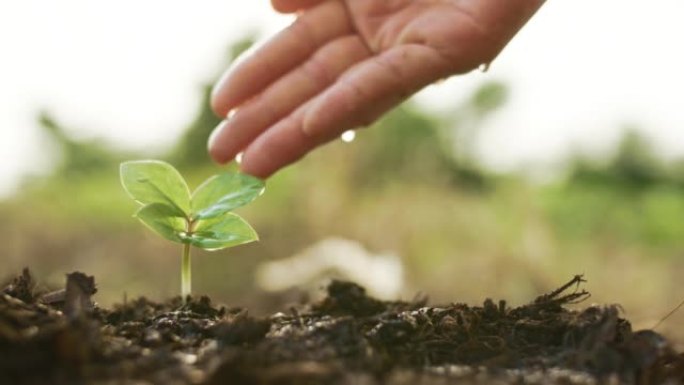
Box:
[121,160,190,216]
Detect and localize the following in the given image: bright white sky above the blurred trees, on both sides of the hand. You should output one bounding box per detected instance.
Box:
[0,0,684,195]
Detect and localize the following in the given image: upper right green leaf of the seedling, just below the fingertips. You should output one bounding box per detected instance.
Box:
[192,173,264,219]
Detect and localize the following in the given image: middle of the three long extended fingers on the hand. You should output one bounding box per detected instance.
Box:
[209,35,370,163]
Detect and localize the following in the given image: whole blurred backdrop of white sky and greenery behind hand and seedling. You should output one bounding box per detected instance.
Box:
[0,0,684,341]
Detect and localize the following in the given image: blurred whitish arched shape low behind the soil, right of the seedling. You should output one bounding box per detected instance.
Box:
[256,238,404,299]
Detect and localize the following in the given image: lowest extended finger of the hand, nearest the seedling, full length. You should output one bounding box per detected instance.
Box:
[236,45,450,178]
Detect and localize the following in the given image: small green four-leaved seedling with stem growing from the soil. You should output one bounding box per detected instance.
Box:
[120,160,264,301]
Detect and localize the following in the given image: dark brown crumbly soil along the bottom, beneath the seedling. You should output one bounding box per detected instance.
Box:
[0,270,684,385]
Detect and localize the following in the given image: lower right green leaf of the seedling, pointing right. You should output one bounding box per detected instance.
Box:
[185,213,259,250]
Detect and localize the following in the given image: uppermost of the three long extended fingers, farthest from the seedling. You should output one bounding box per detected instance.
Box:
[211,1,352,116]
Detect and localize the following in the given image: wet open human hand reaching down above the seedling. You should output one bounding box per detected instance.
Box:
[209,0,543,178]
